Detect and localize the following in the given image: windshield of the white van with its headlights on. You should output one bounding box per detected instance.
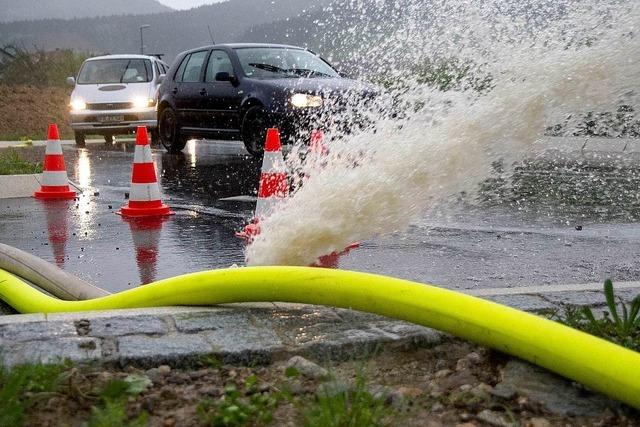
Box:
[78,58,153,84]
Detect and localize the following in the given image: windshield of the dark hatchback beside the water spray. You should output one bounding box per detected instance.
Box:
[235,47,338,79]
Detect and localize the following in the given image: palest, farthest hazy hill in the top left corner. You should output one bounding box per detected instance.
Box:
[0,0,173,22]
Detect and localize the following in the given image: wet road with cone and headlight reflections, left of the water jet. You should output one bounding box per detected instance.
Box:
[0,142,260,291]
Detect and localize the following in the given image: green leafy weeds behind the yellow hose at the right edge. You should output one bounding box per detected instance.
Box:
[553,279,640,351]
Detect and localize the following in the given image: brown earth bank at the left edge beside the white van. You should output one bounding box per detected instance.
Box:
[0,85,73,141]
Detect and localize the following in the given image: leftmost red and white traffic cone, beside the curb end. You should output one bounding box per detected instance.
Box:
[33,123,76,200]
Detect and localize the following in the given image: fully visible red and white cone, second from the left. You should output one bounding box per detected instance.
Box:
[116,126,173,217]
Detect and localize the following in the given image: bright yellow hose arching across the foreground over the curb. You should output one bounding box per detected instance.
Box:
[0,267,640,409]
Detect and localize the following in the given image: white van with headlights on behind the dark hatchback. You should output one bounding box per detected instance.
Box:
[67,55,169,147]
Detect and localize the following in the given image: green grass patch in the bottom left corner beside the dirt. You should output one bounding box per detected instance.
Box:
[0,364,67,427]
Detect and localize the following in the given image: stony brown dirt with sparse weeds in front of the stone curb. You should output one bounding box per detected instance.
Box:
[29,341,640,427]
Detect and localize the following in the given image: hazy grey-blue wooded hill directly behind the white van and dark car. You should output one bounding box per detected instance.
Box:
[0,0,330,62]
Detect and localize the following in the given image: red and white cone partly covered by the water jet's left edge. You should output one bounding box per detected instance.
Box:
[236,128,289,241]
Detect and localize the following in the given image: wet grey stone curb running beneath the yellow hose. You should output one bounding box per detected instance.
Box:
[0,282,640,368]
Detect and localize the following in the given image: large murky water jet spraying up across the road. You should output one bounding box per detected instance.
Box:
[246,0,640,265]
